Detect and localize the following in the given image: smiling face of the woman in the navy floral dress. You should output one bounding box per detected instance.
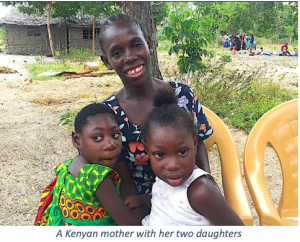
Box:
[101,20,151,86]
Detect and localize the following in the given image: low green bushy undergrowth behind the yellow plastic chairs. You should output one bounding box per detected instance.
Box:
[170,63,298,132]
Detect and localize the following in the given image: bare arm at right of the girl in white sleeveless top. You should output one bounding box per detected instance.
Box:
[188,176,244,226]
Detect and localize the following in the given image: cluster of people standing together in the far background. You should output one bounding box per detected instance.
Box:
[222,33,256,53]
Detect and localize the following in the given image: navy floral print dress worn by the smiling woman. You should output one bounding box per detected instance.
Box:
[102,82,213,194]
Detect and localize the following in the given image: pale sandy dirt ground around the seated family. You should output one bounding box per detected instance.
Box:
[0,52,298,226]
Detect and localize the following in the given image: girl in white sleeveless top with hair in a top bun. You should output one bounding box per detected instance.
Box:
[126,91,243,226]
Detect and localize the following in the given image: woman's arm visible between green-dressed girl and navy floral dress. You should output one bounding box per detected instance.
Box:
[114,161,138,199]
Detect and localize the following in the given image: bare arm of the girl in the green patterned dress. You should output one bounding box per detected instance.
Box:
[95,176,150,225]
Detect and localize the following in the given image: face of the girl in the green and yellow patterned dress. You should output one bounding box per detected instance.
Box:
[72,114,122,168]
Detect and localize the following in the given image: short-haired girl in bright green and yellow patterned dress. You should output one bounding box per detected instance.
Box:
[35,103,149,226]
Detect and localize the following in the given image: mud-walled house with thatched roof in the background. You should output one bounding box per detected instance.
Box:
[0,8,104,55]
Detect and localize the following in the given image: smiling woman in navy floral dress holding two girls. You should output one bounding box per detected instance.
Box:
[99,14,213,198]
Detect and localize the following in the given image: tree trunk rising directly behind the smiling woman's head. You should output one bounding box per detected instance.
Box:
[118,2,163,79]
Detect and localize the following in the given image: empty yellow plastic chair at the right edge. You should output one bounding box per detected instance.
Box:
[244,100,298,226]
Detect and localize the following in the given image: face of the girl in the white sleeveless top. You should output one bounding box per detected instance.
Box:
[144,126,197,186]
